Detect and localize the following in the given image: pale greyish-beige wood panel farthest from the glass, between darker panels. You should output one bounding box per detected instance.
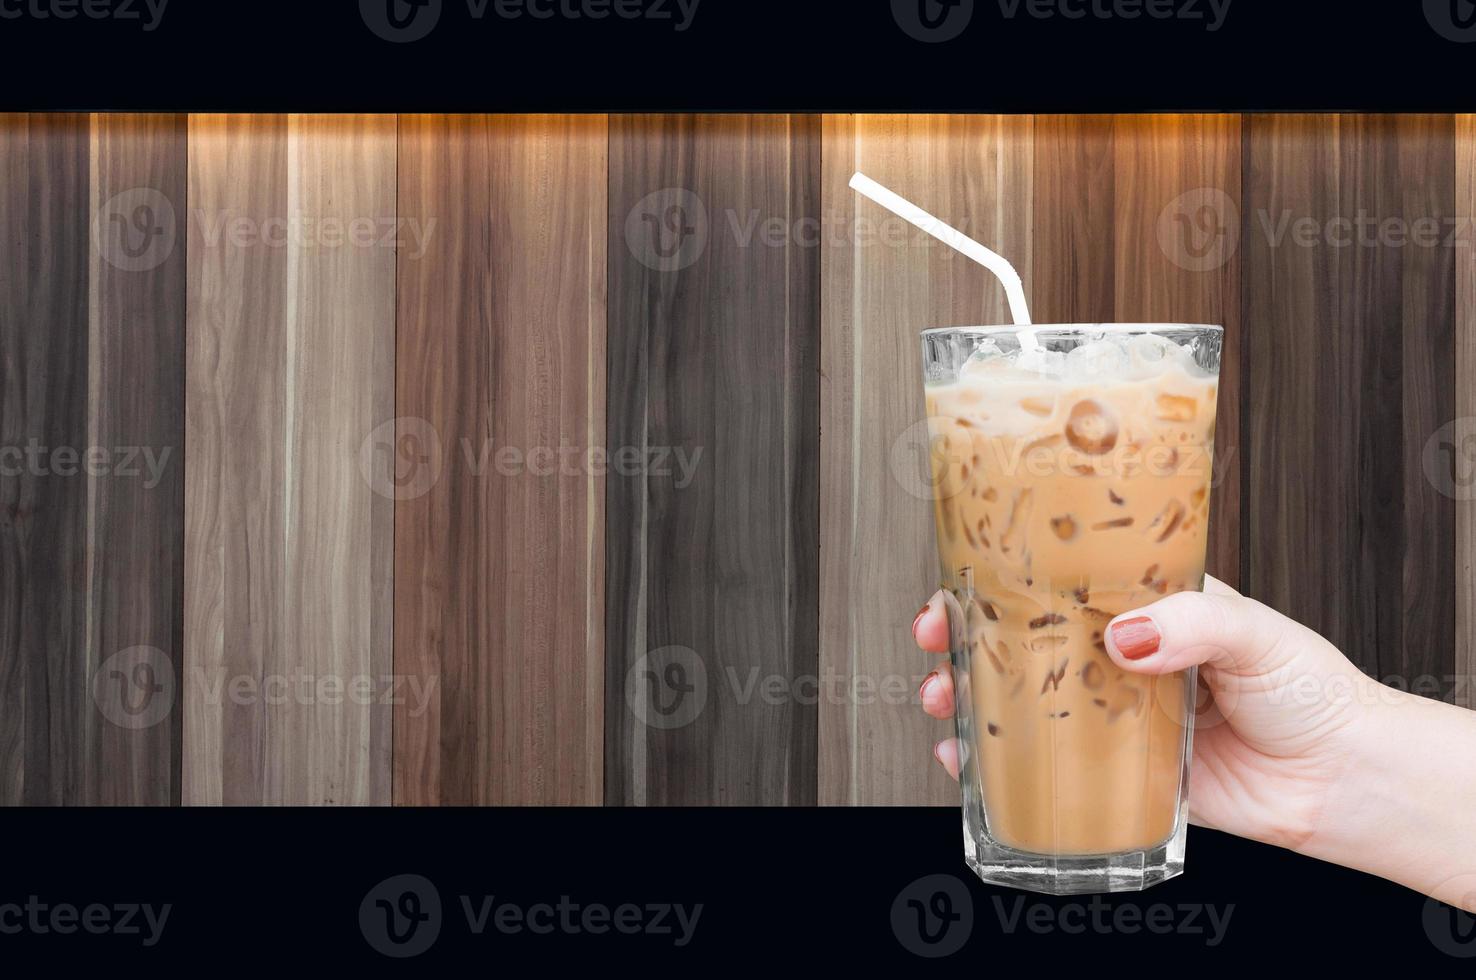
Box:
[185,115,396,804]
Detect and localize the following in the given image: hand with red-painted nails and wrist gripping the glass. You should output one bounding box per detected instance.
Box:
[912,579,1476,912]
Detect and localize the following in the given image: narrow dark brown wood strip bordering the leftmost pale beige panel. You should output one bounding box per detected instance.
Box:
[87,114,187,806]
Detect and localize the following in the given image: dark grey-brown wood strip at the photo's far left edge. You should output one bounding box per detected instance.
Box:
[0,114,97,806]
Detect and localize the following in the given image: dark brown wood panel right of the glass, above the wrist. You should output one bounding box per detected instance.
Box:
[1244,115,1469,694]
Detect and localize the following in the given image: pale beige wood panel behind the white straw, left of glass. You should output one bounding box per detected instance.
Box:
[821,115,1036,804]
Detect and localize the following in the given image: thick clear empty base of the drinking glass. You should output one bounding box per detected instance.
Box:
[967,828,1184,894]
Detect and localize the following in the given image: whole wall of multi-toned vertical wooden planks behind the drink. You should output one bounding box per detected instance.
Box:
[0,115,1476,804]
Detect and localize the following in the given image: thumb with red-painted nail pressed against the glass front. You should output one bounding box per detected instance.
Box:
[1106,590,1297,674]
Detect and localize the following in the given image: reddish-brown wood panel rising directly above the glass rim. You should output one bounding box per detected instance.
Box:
[1032,115,1241,586]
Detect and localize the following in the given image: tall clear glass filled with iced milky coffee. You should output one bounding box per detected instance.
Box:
[924,326,1221,891]
